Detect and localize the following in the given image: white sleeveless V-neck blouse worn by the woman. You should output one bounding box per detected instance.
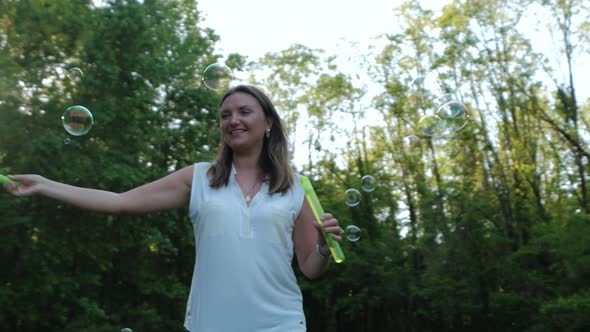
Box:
[184,163,306,332]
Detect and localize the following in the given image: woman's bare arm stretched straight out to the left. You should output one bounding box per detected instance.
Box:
[4,165,193,214]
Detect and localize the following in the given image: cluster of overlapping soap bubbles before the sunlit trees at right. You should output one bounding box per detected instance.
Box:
[402,72,469,155]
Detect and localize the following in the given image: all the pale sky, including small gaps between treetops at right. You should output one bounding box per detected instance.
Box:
[197,0,590,170]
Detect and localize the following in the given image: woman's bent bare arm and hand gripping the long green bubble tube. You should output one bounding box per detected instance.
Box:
[293,199,343,279]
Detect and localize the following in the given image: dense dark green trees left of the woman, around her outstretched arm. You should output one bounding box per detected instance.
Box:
[0,1,218,331]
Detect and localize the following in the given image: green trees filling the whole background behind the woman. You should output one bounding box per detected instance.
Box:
[0,0,590,332]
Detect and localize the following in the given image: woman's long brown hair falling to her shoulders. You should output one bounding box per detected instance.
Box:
[207,85,293,194]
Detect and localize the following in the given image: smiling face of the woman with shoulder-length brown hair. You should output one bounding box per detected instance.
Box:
[219,92,270,151]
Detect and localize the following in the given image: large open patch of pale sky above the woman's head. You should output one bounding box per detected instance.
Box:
[198,0,410,60]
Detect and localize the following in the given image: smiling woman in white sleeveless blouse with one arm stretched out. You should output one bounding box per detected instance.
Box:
[4,85,343,332]
